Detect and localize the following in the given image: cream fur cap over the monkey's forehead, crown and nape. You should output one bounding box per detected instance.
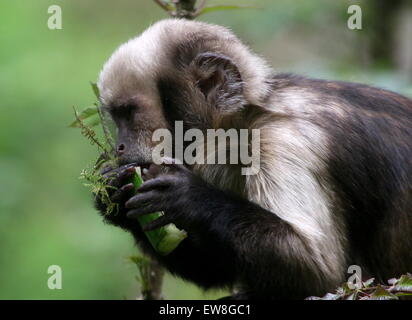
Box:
[98,19,272,105]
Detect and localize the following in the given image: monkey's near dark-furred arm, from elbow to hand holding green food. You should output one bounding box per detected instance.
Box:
[126,166,334,298]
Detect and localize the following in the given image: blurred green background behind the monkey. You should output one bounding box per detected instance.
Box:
[0,0,412,299]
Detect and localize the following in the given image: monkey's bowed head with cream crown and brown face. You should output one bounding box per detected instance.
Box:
[98,19,272,168]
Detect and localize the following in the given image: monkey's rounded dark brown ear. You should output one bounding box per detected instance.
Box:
[192,52,242,98]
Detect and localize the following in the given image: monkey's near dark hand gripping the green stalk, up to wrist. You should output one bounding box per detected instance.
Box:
[126,163,214,233]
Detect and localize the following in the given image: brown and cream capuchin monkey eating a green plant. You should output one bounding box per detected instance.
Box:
[96,19,412,299]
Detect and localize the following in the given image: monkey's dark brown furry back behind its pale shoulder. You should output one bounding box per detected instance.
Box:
[271,74,412,280]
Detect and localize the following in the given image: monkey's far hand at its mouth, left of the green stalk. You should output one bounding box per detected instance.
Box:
[95,164,136,229]
